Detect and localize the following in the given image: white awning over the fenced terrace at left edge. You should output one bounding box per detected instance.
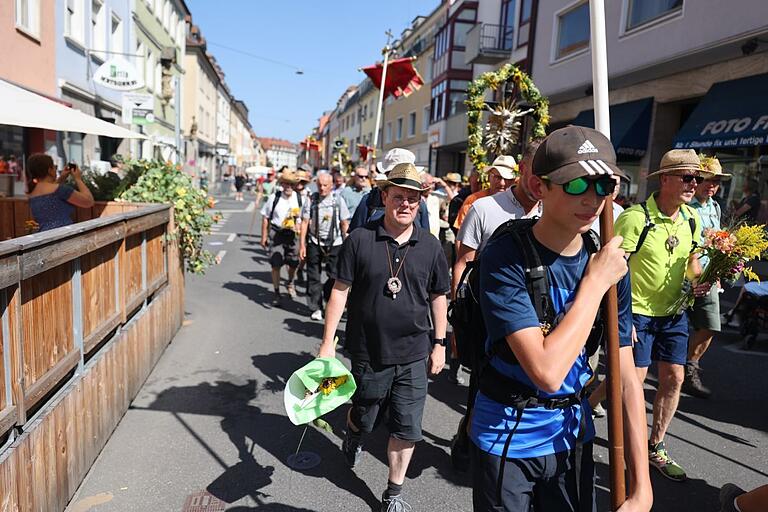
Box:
[0,80,147,139]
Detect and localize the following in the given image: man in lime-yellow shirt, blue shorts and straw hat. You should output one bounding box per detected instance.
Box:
[616,150,709,481]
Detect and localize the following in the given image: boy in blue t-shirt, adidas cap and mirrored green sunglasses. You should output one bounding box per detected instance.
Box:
[470,126,653,512]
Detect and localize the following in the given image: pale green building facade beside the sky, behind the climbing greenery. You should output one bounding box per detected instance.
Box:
[131,0,190,161]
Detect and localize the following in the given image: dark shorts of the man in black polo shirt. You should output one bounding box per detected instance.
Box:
[351,359,427,443]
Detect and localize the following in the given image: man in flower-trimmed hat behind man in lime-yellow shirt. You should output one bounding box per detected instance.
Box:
[683,155,731,398]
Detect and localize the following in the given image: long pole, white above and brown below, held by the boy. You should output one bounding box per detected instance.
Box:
[589,0,627,510]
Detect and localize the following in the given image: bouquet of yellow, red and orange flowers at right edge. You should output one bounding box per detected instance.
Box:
[676,224,768,312]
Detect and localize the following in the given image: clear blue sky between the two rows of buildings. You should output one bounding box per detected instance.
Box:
[186,0,439,142]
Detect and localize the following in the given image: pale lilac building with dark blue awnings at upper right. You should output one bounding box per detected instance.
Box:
[533,0,768,203]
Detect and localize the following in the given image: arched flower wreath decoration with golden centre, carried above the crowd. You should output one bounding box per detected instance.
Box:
[464,64,549,173]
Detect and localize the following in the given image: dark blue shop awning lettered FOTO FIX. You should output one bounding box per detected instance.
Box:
[675,73,768,149]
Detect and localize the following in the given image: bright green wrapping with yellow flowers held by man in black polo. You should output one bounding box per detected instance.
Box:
[283,357,357,425]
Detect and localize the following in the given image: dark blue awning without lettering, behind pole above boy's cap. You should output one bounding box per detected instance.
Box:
[571,98,653,158]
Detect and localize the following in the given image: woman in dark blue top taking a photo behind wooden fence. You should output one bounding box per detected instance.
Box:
[26,153,93,231]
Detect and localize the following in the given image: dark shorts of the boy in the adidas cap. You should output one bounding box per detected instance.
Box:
[472,440,597,512]
